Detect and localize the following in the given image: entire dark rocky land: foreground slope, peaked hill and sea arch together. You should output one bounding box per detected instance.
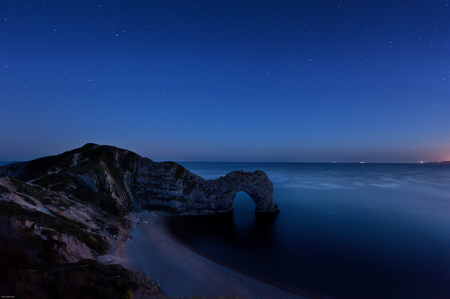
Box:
[0,144,279,298]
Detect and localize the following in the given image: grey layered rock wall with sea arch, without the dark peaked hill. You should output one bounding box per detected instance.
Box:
[133,159,279,215]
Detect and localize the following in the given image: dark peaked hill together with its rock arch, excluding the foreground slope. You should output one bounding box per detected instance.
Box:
[0,144,279,215]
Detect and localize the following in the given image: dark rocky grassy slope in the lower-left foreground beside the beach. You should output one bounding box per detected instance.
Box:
[0,177,162,299]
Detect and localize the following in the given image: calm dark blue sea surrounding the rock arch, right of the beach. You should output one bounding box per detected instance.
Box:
[170,163,450,298]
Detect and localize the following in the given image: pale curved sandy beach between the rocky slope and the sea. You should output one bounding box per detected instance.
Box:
[109,213,313,298]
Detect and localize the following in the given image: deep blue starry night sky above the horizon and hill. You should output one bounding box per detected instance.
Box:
[0,0,450,162]
